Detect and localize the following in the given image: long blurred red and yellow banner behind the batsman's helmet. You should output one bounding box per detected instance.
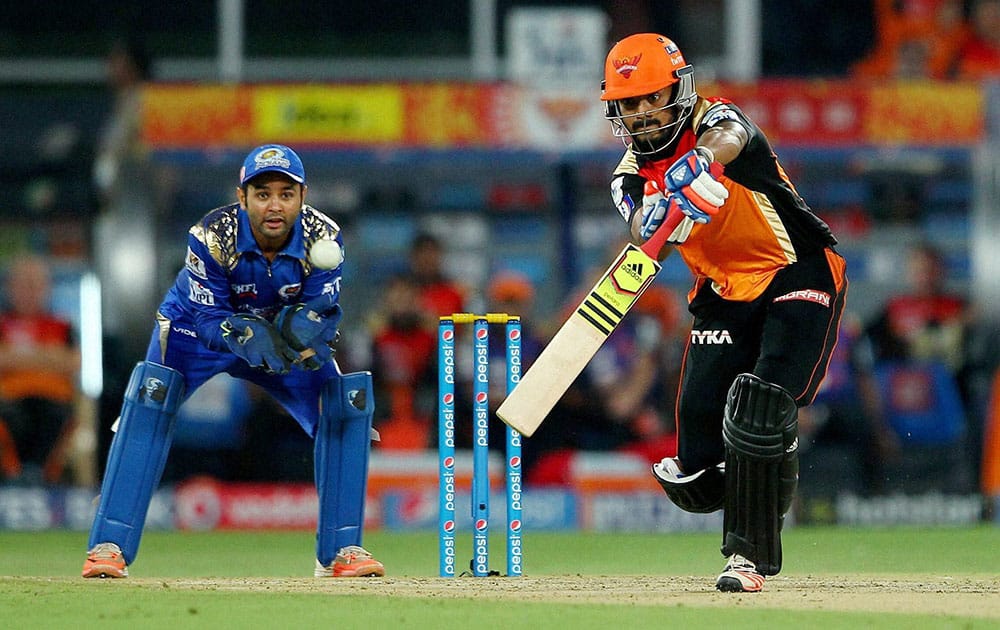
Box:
[143,80,986,150]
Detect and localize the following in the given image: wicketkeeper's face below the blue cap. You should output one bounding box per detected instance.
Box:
[236,173,306,254]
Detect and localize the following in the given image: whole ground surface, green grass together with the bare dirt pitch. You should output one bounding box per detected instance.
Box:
[0,526,1000,630]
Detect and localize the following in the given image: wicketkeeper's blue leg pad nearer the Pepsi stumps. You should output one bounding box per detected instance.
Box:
[315,372,375,566]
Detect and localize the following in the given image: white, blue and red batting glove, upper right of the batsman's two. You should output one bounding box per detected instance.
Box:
[663,149,729,223]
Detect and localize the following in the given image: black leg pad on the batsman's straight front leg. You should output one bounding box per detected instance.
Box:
[722,374,799,575]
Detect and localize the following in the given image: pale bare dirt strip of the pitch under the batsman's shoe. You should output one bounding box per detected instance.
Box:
[160,576,1000,619]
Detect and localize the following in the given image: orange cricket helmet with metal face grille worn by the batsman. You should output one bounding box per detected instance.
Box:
[601,33,698,155]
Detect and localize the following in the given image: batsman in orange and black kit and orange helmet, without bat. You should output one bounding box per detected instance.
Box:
[601,33,847,592]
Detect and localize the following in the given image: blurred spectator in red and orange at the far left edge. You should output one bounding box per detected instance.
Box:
[0,256,80,483]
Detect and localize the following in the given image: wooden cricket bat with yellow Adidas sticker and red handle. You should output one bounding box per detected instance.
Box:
[497,213,686,437]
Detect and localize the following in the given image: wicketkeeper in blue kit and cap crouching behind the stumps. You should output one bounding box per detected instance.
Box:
[83,144,385,577]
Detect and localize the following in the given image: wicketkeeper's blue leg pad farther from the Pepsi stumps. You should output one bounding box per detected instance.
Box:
[89,361,184,564]
